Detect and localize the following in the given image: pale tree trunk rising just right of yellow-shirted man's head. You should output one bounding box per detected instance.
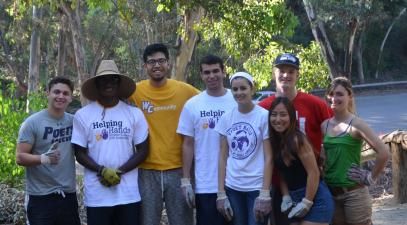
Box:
[174,7,205,81]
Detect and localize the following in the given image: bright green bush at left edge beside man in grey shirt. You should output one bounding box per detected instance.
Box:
[0,86,46,186]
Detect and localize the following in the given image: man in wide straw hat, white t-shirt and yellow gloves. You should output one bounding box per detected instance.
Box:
[72,60,148,225]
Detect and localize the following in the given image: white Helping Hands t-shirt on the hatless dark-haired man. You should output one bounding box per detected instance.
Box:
[177,90,236,193]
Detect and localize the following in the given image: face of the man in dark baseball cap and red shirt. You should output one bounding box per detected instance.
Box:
[273,65,299,93]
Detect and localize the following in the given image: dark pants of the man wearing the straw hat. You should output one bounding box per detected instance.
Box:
[86,202,141,225]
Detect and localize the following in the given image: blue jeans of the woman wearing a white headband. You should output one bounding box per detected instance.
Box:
[225,187,268,225]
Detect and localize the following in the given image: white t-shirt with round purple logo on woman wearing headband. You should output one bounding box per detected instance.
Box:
[215,105,269,191]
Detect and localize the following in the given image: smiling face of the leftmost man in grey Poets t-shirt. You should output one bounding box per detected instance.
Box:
[47,83,72,111]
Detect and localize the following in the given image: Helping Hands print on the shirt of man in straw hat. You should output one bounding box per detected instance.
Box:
[92,120,131,141]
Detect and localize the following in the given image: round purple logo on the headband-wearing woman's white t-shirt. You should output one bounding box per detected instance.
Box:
[226,122,257,160]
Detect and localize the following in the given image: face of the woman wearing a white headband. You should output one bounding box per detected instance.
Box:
[231,77,254,104]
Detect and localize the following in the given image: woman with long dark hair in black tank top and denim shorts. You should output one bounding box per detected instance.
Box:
[269,97,334,225]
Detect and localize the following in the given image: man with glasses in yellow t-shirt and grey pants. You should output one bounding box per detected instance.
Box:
[129,44,199,225]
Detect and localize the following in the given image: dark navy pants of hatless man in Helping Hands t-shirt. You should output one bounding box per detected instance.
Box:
[195,193,232,225]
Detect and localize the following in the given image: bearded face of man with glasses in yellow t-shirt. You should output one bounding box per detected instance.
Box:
[144,52,170,83]
